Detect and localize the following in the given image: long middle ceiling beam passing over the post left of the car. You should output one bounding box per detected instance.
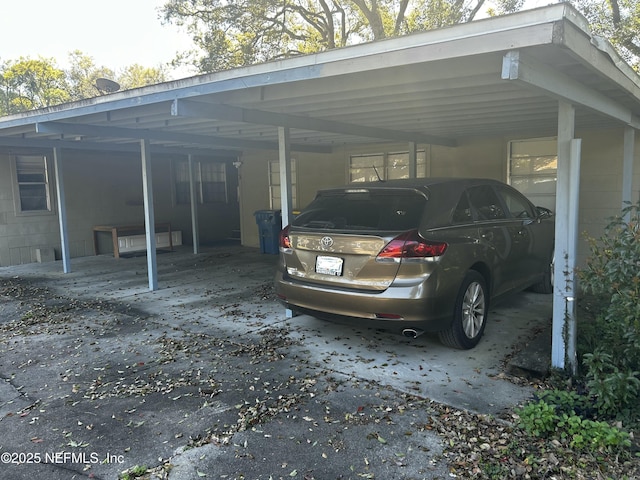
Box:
[171,99,456,147]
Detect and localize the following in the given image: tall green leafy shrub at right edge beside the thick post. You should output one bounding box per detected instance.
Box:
[579,203,640,417]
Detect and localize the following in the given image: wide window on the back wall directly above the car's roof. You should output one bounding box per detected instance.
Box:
[349,150,426,183]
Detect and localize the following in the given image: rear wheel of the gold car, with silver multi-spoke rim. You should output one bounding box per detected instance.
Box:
[439,271,489,349]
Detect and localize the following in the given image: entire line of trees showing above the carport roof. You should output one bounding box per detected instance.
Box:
[0,0,640,115]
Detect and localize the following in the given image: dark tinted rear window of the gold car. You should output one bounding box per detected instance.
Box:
[293,189,426,231]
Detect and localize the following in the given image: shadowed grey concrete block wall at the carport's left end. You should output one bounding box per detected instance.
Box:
[0,151,239,267]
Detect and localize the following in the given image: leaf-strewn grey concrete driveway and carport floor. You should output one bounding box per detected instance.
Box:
[0,246,551,479]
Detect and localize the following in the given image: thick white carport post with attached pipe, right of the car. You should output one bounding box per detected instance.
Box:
[551,101,581,374]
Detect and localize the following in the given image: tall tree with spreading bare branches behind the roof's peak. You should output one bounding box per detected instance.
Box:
[161,0,640,73]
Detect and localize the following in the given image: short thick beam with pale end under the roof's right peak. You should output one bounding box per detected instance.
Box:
[502,50,640,129]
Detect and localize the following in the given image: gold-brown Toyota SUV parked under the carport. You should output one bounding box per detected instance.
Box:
[275,178,554,349]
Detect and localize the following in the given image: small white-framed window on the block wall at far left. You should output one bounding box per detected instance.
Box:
[15,156,51,212]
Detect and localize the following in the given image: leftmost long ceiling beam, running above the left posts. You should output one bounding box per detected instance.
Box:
[36,122,331,153]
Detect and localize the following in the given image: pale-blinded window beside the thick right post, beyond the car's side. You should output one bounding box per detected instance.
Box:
[509,138,558,210]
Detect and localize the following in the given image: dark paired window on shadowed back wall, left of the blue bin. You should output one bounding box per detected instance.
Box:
[174,160,227,205]
